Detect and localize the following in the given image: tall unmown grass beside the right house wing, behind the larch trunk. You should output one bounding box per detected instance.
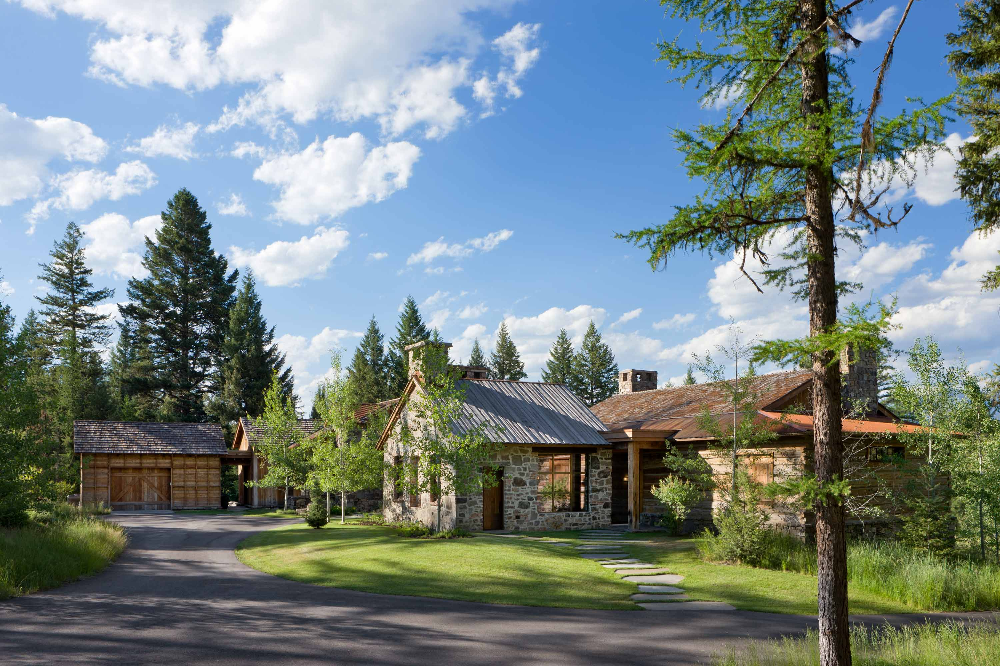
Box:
[698,530,1000,611]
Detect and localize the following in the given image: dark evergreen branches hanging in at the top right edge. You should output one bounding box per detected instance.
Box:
[947,0,1000,289]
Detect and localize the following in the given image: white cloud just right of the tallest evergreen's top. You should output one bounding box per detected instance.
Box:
[229,227,349,287]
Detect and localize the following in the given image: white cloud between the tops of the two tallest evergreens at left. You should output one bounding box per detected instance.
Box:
[80,213,163,279]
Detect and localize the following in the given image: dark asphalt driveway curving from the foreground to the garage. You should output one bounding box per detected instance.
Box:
[0,514,992,666]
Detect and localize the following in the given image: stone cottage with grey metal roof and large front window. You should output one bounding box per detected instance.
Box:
[379,342,612,531]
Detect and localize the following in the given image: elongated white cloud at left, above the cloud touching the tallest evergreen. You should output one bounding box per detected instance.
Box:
[26,161,156,233]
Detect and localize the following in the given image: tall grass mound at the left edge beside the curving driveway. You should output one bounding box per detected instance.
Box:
[0,511,126,599]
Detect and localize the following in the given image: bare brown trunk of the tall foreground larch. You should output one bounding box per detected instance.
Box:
[800,0,851,666]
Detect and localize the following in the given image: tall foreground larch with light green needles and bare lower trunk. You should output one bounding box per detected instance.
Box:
[624,0,946,666]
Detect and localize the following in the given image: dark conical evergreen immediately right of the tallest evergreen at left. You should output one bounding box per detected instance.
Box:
[212,272,293,426]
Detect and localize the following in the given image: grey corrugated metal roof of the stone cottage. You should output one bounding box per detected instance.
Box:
[455,379,608,446]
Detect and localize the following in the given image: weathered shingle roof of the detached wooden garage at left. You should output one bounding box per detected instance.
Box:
[73,421,226,456]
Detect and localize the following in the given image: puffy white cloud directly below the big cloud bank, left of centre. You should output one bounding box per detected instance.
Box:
[253,132,420,224]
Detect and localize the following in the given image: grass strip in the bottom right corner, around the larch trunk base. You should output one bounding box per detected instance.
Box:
[715,623,1000,666]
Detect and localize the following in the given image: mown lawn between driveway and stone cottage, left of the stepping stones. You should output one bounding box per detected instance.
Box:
[236,523,636,610]
